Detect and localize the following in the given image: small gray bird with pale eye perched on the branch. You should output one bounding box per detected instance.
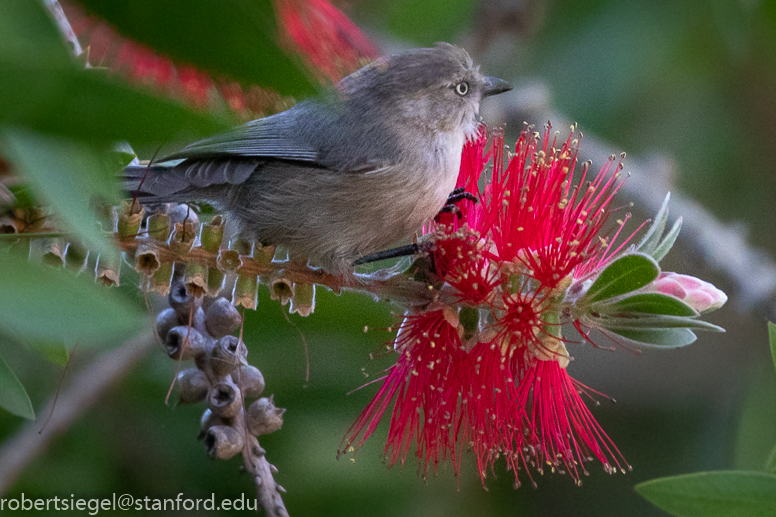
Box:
[126,43,511,274]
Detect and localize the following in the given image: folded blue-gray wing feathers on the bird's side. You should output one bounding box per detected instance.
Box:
[160,103,320,162]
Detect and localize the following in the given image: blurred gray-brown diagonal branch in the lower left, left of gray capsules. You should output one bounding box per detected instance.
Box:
[0,331,155,494]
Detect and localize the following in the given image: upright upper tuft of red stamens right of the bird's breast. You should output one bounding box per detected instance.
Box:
[482,124,620,288]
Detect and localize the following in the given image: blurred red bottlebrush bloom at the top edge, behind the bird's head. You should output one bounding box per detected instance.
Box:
[275,0,379,81]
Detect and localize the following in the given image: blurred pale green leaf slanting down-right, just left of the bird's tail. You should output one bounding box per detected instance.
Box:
[0,128,119,253]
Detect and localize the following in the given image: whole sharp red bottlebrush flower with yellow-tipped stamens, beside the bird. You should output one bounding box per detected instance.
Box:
[345,126,636,485]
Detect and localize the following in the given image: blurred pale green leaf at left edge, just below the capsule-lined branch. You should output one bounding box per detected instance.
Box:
[0,247,147,345]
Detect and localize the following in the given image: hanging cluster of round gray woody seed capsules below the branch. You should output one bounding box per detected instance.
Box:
[156,280,286,515]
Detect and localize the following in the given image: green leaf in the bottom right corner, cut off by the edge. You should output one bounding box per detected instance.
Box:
[635,470,776,517]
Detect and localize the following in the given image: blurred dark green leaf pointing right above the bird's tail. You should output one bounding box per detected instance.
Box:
[0,61,229,146]
